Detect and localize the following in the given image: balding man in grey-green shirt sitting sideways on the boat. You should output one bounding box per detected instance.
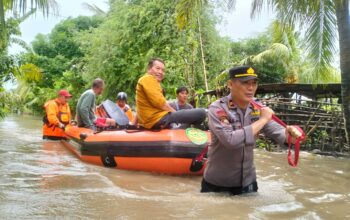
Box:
[76,78,116,129]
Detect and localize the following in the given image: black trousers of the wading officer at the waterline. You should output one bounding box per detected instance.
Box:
[201,178,258,195]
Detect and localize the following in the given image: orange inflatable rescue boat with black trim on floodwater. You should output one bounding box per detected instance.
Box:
[62,101,210,175]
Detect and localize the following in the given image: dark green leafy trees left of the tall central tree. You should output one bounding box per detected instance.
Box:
[15,16,102,113]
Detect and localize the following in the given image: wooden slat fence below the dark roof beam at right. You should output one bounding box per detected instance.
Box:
[260,97,349,152]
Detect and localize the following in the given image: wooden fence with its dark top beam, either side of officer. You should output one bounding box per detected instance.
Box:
[200,83,350,155]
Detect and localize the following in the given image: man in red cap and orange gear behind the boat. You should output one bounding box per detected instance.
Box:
[43,89,72,140]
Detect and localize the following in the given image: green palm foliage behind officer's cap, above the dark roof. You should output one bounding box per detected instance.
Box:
[216,20,340,85]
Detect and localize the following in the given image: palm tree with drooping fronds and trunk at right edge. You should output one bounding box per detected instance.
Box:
[252,0,350,144]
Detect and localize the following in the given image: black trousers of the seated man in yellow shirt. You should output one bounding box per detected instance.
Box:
[153,108,207,129]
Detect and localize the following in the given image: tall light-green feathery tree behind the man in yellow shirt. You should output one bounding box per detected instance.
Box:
[81,0,227,103]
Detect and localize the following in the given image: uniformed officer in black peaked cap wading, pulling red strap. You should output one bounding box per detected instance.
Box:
[201,66,301,195]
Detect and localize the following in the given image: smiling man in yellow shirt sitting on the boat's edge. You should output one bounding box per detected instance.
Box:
[136,58,206,129]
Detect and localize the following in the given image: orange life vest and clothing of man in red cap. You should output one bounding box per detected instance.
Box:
[43,99,71,138]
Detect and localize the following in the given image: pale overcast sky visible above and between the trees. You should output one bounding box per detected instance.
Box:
[10,0,273,54]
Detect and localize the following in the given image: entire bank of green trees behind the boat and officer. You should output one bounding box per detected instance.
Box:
[7,0,342,118]
